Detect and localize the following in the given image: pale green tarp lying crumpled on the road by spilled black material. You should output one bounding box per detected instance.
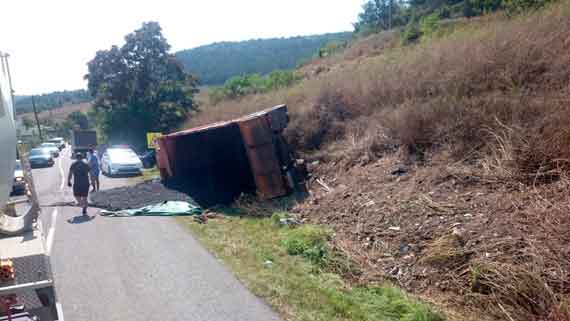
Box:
[101,201,202,217]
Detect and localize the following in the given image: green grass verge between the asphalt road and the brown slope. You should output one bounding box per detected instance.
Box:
[177,214,443,321]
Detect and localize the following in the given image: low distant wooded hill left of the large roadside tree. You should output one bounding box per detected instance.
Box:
[14,89,91,115]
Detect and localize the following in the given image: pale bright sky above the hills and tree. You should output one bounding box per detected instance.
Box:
[0,0,363,95]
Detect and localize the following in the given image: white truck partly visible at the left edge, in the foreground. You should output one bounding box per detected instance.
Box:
[0,52,63,321]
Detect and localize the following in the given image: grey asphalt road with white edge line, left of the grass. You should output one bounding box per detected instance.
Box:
[33,150,279,321]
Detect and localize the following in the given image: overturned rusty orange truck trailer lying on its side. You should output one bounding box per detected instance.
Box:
[157,105,296,206]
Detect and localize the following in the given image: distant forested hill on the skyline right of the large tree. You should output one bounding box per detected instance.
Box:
[176,32,352,85]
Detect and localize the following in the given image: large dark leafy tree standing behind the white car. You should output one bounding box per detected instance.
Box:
[85,22,198,147]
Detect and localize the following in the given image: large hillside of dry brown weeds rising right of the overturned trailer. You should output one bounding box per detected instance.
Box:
[188,1,570,320]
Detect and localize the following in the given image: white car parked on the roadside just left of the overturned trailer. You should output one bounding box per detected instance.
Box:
[101,147,143,176]
